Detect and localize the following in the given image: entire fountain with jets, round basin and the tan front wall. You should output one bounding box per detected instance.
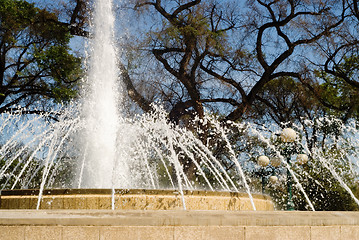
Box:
[0,0,359,239]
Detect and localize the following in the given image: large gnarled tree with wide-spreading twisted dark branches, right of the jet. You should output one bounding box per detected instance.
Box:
[128,0,347,124]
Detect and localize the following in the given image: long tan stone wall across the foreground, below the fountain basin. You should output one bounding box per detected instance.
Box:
[0,210,359,240]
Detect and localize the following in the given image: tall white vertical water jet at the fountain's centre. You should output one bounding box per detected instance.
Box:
[79,0,123,188]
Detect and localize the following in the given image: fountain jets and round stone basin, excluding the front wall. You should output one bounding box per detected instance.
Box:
[0,0,359,213]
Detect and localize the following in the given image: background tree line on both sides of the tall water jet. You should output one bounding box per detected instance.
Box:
[0,0,359,124]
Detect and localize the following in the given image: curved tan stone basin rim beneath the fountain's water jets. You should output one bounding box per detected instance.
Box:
[0,189,274,211]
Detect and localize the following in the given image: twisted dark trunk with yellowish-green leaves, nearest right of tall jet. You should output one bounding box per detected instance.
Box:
[128,0,240,123]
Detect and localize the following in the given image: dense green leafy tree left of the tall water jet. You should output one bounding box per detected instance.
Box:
[0,0,86,112]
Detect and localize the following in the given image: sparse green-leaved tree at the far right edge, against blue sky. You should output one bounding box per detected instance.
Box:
[292,1,359,122]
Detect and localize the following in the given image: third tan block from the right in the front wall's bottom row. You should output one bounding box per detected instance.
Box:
[244,226,310,240]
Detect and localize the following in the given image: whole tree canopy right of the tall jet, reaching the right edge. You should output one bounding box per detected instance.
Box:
[121,0,357,126]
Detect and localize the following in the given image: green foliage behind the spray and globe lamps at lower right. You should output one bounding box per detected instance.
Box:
[236,118,359,211]
